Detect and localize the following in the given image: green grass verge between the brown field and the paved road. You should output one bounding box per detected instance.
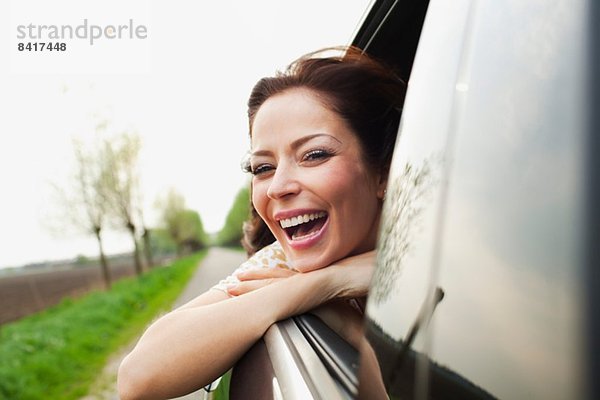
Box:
[0,252,205,400]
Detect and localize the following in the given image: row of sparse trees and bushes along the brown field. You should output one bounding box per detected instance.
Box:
[54,130,208,288]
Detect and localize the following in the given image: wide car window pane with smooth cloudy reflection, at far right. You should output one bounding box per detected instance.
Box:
[429,0,585,399]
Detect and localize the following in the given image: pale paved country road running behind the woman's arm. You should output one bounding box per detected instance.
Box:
[82,247,246,400]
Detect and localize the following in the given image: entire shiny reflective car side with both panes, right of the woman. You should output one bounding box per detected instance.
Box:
[359,0,600,399]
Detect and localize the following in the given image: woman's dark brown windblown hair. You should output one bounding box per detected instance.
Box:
[242,47,406,255]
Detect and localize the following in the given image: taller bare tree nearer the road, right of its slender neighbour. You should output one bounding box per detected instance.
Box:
[102,133,142,275]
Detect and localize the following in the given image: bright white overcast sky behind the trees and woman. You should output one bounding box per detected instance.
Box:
[0,0,370,267]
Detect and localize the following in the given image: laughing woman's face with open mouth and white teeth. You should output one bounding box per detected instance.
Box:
[250,89,384,272]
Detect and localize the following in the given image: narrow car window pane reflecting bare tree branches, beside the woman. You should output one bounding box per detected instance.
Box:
[361,0,469,398]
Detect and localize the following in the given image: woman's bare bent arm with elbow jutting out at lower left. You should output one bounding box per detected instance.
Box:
[118,267,344,400]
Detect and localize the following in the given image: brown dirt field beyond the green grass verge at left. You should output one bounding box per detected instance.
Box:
[0,261,171,325]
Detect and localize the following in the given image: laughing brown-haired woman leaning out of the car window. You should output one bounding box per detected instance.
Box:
[119,49,404,400]
